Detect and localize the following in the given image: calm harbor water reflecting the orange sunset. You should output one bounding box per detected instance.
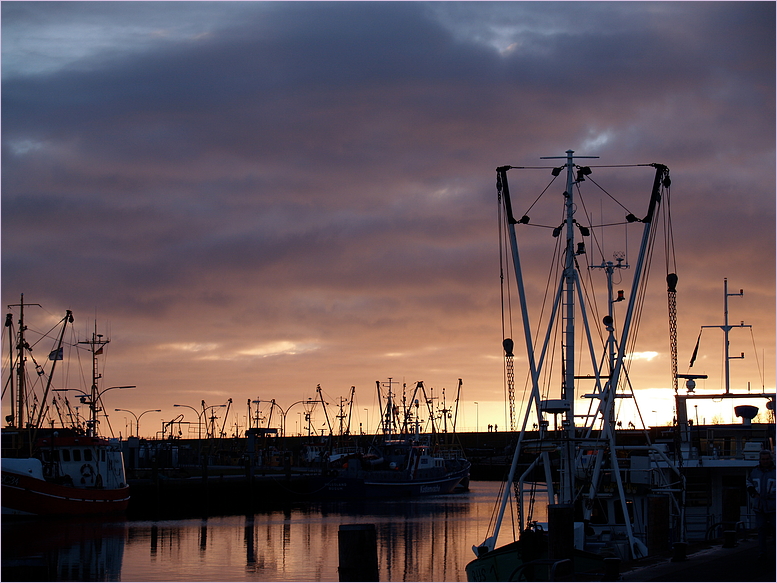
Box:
[2,482,544,581]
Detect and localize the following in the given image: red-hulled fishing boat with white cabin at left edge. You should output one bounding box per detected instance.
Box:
[0,295,130,516]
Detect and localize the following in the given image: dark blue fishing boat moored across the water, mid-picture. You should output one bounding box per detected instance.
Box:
[312,378,471,498]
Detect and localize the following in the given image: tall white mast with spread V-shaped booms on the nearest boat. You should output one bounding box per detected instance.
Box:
[473,150,670,556]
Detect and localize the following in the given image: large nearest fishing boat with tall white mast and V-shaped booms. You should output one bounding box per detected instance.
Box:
[466,150,684,581]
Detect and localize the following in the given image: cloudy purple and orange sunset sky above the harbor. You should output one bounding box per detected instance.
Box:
[0,1,775,435]
